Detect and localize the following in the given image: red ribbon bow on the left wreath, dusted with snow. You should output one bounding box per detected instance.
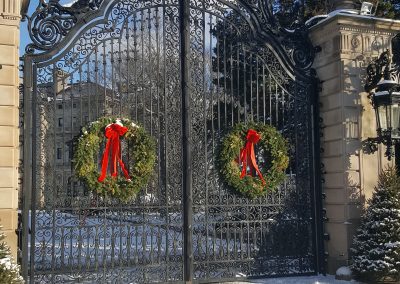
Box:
[98,123,130,182]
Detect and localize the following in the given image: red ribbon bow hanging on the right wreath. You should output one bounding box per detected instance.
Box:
[240,129,265,185]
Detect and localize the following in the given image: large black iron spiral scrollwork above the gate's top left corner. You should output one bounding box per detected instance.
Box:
[25,0,103,54]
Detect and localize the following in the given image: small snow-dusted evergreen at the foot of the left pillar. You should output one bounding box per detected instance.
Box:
[0,229,24,284]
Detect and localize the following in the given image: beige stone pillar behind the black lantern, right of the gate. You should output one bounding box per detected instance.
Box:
[310,14,400,273]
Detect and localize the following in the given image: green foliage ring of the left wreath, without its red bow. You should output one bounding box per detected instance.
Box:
[73,117,156,201]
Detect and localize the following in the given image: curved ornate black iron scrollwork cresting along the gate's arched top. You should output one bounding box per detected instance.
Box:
[26,0,315,81]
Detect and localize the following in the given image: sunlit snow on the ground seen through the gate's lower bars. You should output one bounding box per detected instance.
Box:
[29,210,239,271]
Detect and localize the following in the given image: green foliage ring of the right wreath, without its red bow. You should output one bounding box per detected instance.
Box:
[219,123,289,198]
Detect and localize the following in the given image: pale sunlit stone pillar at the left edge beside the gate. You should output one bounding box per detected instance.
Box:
[0,0,22,257]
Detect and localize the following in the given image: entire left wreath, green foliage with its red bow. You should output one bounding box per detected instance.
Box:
[73,117,156,200]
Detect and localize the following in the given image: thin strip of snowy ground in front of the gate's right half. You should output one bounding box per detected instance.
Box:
[224,275,362,284]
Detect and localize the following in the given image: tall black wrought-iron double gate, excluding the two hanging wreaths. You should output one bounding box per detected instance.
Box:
[23,0,322,283]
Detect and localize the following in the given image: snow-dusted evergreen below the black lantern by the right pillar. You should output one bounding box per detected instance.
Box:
[351,168,400,281]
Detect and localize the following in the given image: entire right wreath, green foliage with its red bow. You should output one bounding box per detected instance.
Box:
[219,123,289,198]
